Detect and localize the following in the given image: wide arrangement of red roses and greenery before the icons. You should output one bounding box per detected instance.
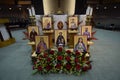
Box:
[33,47,91,75]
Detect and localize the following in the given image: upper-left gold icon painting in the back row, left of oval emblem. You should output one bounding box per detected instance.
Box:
[42,17,52,30]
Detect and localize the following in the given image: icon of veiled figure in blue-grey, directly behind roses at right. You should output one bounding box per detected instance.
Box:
[74,35,87,52]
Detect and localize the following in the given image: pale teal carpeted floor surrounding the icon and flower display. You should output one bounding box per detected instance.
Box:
[0,29,120,80]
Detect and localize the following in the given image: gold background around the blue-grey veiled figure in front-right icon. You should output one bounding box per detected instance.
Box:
[74,35,87,52]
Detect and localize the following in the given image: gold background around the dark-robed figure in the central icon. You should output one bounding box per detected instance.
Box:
[55,30,67,46]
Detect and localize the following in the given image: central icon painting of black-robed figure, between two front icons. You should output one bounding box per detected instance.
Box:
[55,30,67,47]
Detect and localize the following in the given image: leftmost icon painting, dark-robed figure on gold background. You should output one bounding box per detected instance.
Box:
[28,26,39,41]
